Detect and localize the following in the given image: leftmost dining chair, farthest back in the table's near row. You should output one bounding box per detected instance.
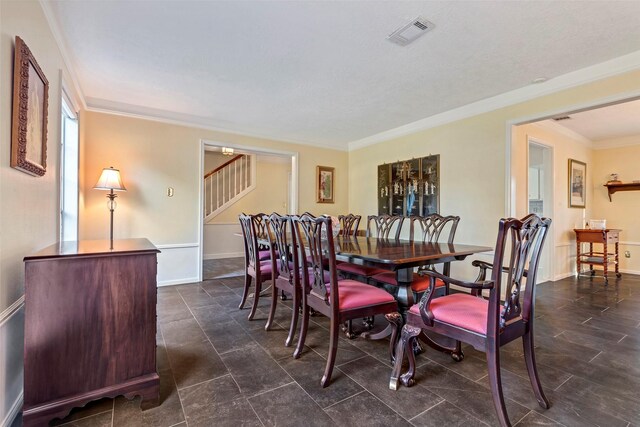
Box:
[238,213,272,320]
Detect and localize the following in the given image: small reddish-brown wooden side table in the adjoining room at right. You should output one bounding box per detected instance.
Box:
[573,228,622,283]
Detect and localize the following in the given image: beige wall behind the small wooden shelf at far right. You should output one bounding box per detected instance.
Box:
[590,140,640,274]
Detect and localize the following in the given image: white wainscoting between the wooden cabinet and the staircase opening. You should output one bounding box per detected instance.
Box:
[156,243,201,286]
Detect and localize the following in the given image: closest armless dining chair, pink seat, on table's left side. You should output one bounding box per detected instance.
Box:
[292,215,398,387]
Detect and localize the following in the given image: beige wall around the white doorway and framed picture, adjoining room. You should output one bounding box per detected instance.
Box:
[512,124,594,279]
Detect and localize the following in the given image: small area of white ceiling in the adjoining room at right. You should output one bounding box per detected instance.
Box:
[544,100,640,145]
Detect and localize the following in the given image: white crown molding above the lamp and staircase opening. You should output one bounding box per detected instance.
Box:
[86,98,348,151]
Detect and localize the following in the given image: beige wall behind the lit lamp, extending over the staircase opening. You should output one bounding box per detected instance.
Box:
[80,112,348,244]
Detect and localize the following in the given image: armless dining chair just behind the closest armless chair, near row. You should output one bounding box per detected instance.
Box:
[263,213,301,347]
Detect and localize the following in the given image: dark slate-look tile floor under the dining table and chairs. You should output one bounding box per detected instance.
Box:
[15,259,640,427]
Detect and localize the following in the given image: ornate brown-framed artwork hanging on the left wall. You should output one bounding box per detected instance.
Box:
[10,36,49,176]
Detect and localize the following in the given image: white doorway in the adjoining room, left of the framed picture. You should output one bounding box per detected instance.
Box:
[527,137,554,282]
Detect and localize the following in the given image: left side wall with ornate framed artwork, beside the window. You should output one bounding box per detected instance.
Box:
[0,0,81,423]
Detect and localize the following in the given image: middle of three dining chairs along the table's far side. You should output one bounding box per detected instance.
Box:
[338,215,404,283]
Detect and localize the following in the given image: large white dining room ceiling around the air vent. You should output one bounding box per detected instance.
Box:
[44,0,640,148]
